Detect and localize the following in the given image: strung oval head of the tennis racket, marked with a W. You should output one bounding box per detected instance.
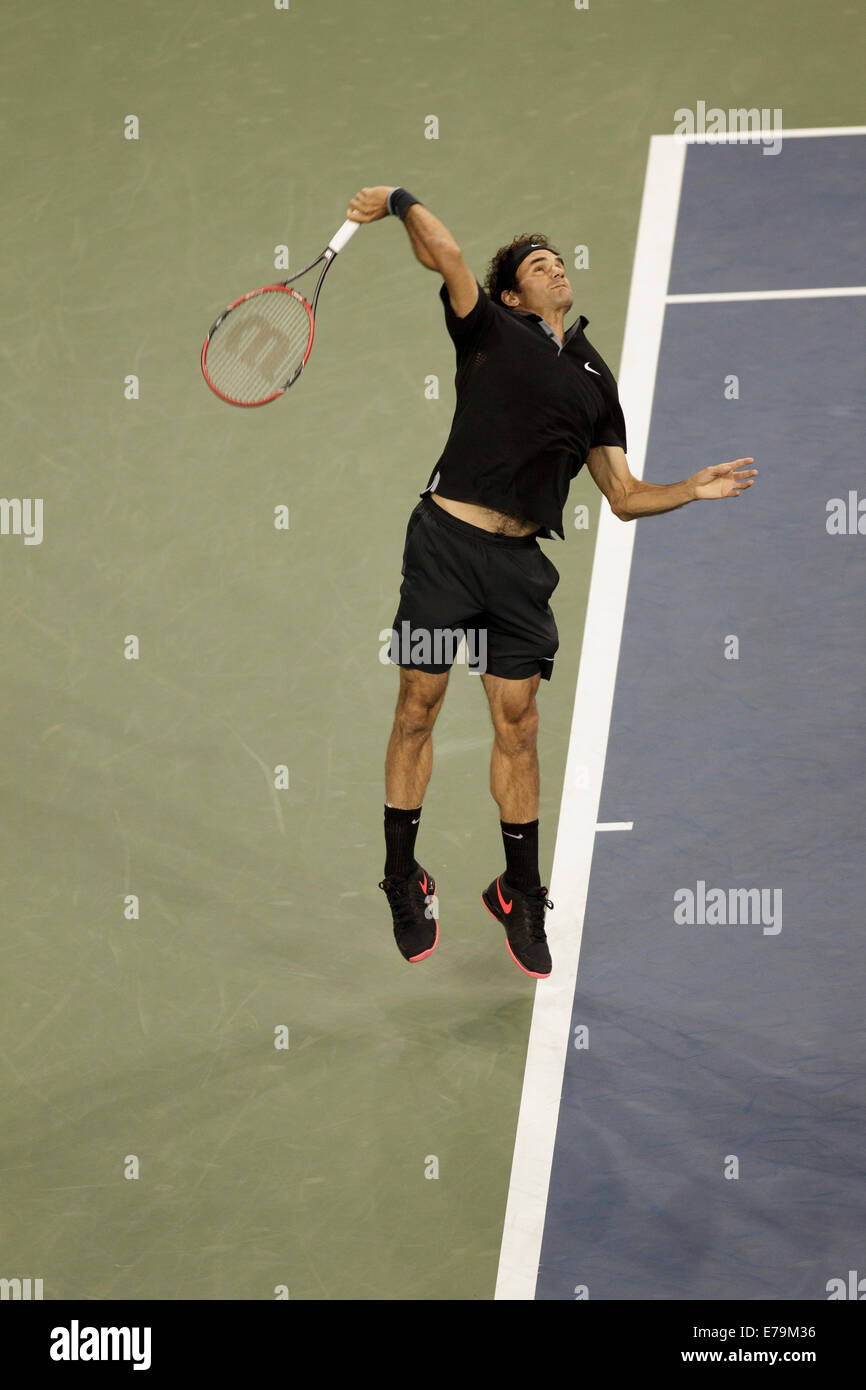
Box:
[204,288,313,404]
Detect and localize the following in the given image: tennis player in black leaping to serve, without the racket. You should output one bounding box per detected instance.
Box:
[346,186,756,980]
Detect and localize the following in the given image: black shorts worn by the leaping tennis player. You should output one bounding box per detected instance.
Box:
[389,496,559,681]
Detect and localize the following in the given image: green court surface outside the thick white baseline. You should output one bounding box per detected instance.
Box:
[0,0,862,1300]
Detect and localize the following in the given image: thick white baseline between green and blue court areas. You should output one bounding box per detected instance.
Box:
[493,135,685,1300]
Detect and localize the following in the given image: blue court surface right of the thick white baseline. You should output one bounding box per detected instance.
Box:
[535,133,866,1300]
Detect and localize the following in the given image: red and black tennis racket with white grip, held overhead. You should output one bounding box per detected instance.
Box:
[202,221,361,406]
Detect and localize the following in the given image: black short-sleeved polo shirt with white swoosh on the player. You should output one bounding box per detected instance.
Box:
[421,285,626,537]
